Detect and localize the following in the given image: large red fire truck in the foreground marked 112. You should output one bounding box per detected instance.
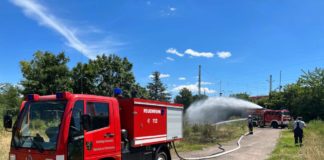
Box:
[4,92,183,160]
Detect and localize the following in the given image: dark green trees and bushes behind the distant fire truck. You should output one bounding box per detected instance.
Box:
[231,68,324,121]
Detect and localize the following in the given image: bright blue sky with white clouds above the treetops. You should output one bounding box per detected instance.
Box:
[0,0,324,96]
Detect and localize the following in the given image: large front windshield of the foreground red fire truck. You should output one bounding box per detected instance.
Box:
[12,101,66,151]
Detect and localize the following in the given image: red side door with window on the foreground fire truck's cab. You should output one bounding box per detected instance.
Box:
[84,101,116,158]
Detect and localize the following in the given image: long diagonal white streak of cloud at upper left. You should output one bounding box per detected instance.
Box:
[11,0,122,59]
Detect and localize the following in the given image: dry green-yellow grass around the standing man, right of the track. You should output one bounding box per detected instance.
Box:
[269,120,324,160]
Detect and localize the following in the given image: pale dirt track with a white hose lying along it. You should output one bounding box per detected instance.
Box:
[172,128,281,160]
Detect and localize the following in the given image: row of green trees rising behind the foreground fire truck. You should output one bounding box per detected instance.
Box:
[0,51,171,112]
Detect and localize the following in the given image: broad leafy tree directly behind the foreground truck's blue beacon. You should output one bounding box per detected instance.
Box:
[72,54,145,97]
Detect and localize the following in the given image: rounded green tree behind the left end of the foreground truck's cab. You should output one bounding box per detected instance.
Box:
[20,51,71,95]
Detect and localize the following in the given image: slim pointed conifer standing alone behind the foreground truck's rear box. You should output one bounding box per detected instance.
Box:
[146,71,171,102]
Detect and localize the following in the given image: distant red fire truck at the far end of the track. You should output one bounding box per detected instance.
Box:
[252,109,291,128]
